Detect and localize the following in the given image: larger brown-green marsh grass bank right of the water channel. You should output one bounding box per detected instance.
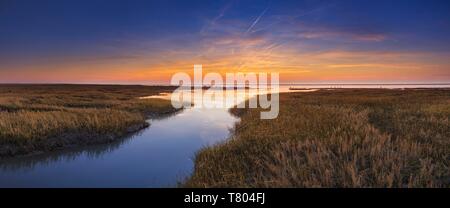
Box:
[184,89,450,187]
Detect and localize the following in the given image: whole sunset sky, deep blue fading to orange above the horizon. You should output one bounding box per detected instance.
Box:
[0,0,450,84]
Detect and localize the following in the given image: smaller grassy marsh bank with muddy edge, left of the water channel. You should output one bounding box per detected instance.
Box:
[0,85,175,157]
